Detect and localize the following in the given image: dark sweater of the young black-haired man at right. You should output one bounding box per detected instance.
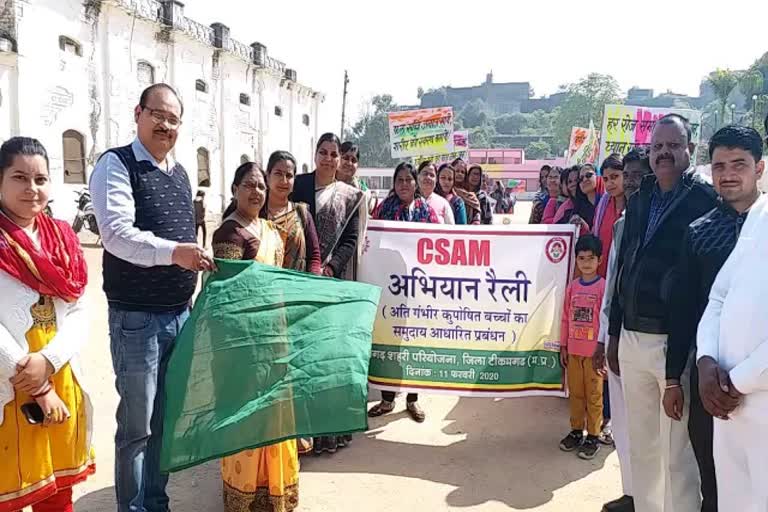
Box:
[667,203,747,379]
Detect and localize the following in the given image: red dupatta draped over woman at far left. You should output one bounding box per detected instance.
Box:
[0,213,88,302]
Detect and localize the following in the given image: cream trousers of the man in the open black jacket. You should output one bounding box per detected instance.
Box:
[619,329,704,512]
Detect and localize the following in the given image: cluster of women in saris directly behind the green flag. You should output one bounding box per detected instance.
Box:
[213,134,367,512]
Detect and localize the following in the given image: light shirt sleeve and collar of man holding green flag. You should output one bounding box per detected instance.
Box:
[89,138,177,267]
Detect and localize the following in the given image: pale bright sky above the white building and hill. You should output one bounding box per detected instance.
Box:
[185,0,768,132]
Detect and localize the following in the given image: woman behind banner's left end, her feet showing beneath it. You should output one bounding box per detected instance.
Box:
[368,162,440,423]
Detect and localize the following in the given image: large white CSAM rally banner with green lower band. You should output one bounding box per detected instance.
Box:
[358,221,575,397]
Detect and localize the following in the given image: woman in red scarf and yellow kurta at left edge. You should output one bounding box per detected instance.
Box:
[0,137,95,512]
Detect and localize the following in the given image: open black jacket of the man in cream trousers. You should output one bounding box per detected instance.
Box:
[608,171,717,336]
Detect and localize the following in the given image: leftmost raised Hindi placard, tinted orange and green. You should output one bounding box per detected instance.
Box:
[388,107,453,159]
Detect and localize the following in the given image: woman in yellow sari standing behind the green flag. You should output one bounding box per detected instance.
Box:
[213,163,299,512]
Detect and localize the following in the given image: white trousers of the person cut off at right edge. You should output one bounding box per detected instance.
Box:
[712,406,768,512]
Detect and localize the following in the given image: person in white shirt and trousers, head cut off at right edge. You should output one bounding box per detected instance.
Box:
[697,192,768,512]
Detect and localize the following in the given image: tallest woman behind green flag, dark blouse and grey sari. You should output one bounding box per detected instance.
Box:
[291,133,365,455]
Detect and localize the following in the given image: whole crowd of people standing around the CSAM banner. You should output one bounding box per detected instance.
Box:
[0,79,768,512]
